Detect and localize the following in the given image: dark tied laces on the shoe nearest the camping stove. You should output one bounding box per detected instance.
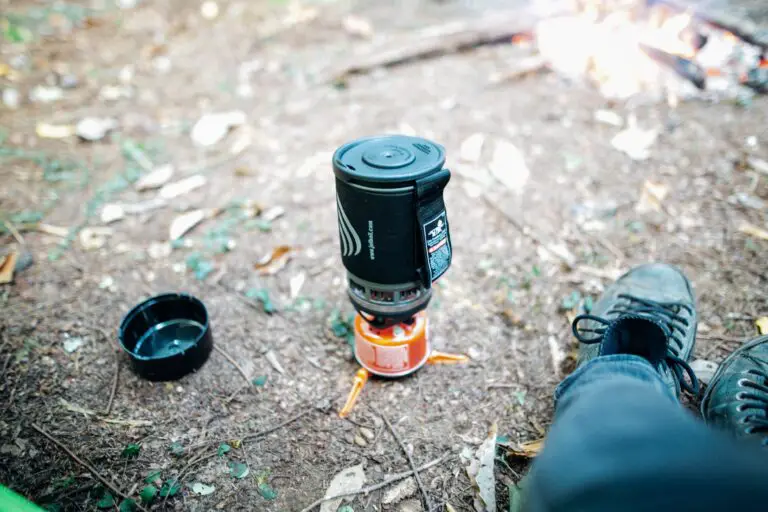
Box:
[572,293,699,395]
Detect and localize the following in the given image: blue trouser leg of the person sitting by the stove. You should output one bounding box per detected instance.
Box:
[524,355,768,512]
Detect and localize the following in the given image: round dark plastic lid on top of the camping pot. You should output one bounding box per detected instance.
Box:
[333,135,445,187]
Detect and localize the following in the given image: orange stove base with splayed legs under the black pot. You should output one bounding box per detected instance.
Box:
[339,311,469,418]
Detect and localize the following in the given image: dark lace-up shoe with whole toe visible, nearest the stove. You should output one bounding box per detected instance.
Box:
[572,263,698,397]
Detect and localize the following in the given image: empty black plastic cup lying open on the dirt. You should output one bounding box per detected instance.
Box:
[119,293,213,381]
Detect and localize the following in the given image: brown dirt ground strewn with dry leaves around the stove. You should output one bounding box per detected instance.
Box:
[0,0,768,511]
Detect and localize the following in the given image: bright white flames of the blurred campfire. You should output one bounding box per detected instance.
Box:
[535,0,739,100]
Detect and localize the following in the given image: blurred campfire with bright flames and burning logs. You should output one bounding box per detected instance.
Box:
[532,0,768,104]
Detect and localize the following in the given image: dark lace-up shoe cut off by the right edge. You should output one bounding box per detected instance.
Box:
[701,336,768,446]
